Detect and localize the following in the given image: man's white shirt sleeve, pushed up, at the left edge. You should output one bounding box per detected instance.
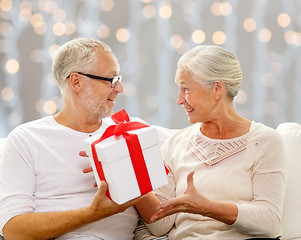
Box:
[0,129,35,234]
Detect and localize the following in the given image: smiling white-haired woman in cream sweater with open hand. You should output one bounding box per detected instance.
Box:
[144,46,285,240]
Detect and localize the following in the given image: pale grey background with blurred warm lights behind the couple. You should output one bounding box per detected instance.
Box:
[0,0,301,137]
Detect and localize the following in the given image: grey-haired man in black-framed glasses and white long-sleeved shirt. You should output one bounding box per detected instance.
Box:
[0,38,169,240]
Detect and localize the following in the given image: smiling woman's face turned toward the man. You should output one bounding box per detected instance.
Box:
[176,68,216,123]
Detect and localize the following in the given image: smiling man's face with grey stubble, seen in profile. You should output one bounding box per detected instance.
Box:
[80,50,123,120]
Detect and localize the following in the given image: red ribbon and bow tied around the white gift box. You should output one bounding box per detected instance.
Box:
[91,109,153,199]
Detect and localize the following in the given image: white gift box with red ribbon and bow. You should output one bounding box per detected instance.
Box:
[84,110,168,204]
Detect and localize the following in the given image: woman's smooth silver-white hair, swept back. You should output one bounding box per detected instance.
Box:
[178,45,242,100]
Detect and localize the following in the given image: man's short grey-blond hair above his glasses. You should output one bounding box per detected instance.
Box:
[52,38,112,90]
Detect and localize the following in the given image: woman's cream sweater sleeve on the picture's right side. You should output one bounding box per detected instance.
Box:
[232,129,286,237]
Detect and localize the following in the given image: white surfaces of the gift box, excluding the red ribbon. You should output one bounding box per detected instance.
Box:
[84,126,168,204]
